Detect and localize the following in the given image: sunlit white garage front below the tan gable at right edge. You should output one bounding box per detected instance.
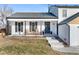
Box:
[70,24,79,46]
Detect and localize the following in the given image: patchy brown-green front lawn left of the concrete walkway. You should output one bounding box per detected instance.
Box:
[0,38,63,55]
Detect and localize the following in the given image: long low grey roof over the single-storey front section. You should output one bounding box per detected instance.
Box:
[7,12,58,19]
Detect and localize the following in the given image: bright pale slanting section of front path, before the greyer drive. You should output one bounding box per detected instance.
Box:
[47,37,64,49]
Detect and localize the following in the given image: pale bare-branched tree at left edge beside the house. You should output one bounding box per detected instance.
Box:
[0,5,13,28]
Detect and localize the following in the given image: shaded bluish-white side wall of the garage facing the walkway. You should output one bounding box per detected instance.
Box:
[58,24,70,44]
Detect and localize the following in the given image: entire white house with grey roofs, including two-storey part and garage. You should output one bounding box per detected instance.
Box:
[6,6,79,46]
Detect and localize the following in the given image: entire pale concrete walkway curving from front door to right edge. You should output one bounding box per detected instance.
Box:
[47,37,79,54]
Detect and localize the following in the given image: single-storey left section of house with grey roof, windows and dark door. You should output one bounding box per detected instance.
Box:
[7,12,58,36]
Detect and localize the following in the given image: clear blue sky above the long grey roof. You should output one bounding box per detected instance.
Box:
[0,4,48,12]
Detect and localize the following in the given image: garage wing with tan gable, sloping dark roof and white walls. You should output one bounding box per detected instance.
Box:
[59,13,79,46]
